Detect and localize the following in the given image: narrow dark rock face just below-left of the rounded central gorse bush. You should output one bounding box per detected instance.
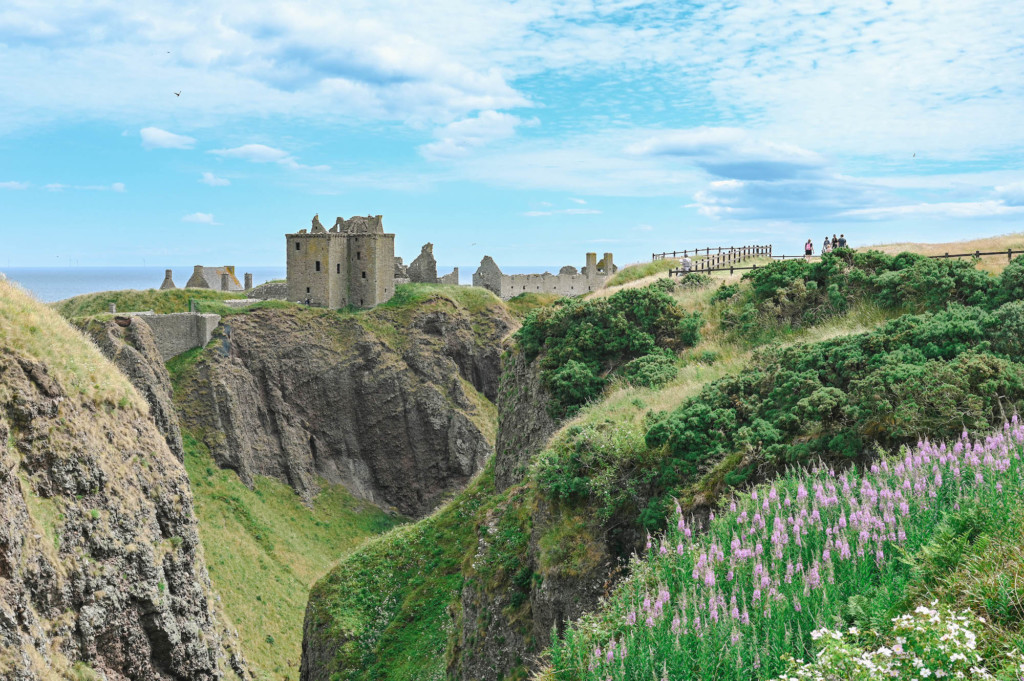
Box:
[495,346,560,491]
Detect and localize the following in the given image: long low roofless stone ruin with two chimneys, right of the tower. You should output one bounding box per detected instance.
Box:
[473,253,617,300]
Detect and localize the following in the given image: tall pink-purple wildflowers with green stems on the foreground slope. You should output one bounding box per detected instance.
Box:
[551,416,1024,681]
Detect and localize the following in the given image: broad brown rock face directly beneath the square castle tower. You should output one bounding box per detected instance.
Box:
[176,297,515,516]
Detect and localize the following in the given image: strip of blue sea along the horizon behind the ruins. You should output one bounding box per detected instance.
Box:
[0,265,558,303]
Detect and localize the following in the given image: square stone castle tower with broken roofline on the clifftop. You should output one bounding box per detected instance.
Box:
[285,215,395,309]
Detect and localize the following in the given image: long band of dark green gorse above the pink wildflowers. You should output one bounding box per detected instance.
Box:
[646,303,1024,499]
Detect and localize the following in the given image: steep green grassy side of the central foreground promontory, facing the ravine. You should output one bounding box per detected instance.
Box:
[310,462,495,681]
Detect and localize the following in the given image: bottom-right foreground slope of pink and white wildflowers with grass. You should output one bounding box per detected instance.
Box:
[551,417,1024,681]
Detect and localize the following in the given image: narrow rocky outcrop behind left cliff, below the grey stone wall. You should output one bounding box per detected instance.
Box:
[82,316,184,461]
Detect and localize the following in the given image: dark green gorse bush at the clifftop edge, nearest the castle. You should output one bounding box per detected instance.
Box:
[516,286,703,418]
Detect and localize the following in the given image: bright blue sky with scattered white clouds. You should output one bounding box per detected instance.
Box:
[0,0,1024,266]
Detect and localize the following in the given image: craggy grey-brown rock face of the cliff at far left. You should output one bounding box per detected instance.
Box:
[0,348,234,681]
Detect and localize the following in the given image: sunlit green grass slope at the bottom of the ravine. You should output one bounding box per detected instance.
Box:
[183,432,400,681]
